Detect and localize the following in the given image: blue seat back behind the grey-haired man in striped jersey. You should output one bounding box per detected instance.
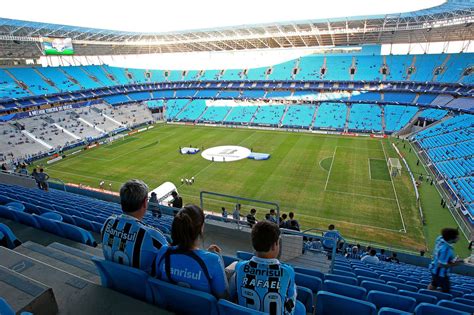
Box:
[91,257,154,303]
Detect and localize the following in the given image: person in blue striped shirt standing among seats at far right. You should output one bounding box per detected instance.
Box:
[428,228,463,293]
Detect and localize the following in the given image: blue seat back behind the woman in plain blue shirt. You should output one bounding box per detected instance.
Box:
[148,279,218,315]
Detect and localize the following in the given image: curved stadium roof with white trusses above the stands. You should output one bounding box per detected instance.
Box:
[0,0,474,57]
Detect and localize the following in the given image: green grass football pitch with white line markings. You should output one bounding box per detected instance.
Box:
[33,125,466,251]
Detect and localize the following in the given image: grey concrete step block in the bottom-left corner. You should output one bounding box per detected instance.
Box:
[0,266,58,315]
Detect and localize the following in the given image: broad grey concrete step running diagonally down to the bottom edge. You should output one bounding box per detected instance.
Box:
[0,247,169,315]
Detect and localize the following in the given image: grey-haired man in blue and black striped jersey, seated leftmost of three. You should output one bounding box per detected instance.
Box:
[102,179,168,273]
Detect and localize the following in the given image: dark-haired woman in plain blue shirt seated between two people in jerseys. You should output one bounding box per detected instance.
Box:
[156,205,228,303]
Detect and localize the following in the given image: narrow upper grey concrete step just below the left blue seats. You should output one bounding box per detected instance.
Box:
[15,242,100,284]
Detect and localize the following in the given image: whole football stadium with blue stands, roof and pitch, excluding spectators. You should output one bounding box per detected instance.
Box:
[0,0,474,315]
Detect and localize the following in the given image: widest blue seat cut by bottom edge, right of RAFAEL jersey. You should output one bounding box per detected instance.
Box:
[316,291,377,315]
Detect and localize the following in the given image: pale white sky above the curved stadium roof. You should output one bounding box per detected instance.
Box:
[0,0,445,32]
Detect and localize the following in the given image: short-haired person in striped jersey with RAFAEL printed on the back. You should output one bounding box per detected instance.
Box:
[230,221,304,314]
